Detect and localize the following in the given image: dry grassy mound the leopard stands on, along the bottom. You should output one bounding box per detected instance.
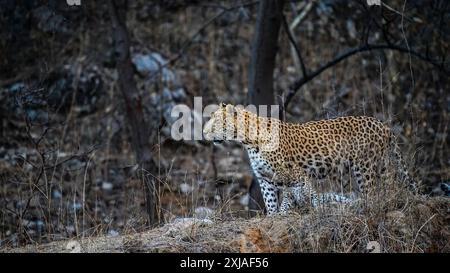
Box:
[3,178,450,252]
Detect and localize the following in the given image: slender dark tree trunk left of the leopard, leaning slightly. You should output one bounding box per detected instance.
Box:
[108,0,160,226]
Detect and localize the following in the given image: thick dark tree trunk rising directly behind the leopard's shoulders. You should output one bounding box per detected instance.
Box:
[248,0,284,215]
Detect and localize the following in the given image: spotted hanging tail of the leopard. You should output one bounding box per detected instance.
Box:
[389,132,419,193]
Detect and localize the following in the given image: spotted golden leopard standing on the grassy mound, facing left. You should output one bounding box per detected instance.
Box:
[203,103,417,215]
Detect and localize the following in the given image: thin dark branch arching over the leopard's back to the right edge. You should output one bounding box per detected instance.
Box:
[284,44,450,108]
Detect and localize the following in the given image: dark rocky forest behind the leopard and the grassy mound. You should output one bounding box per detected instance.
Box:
[0,0,450,250]
